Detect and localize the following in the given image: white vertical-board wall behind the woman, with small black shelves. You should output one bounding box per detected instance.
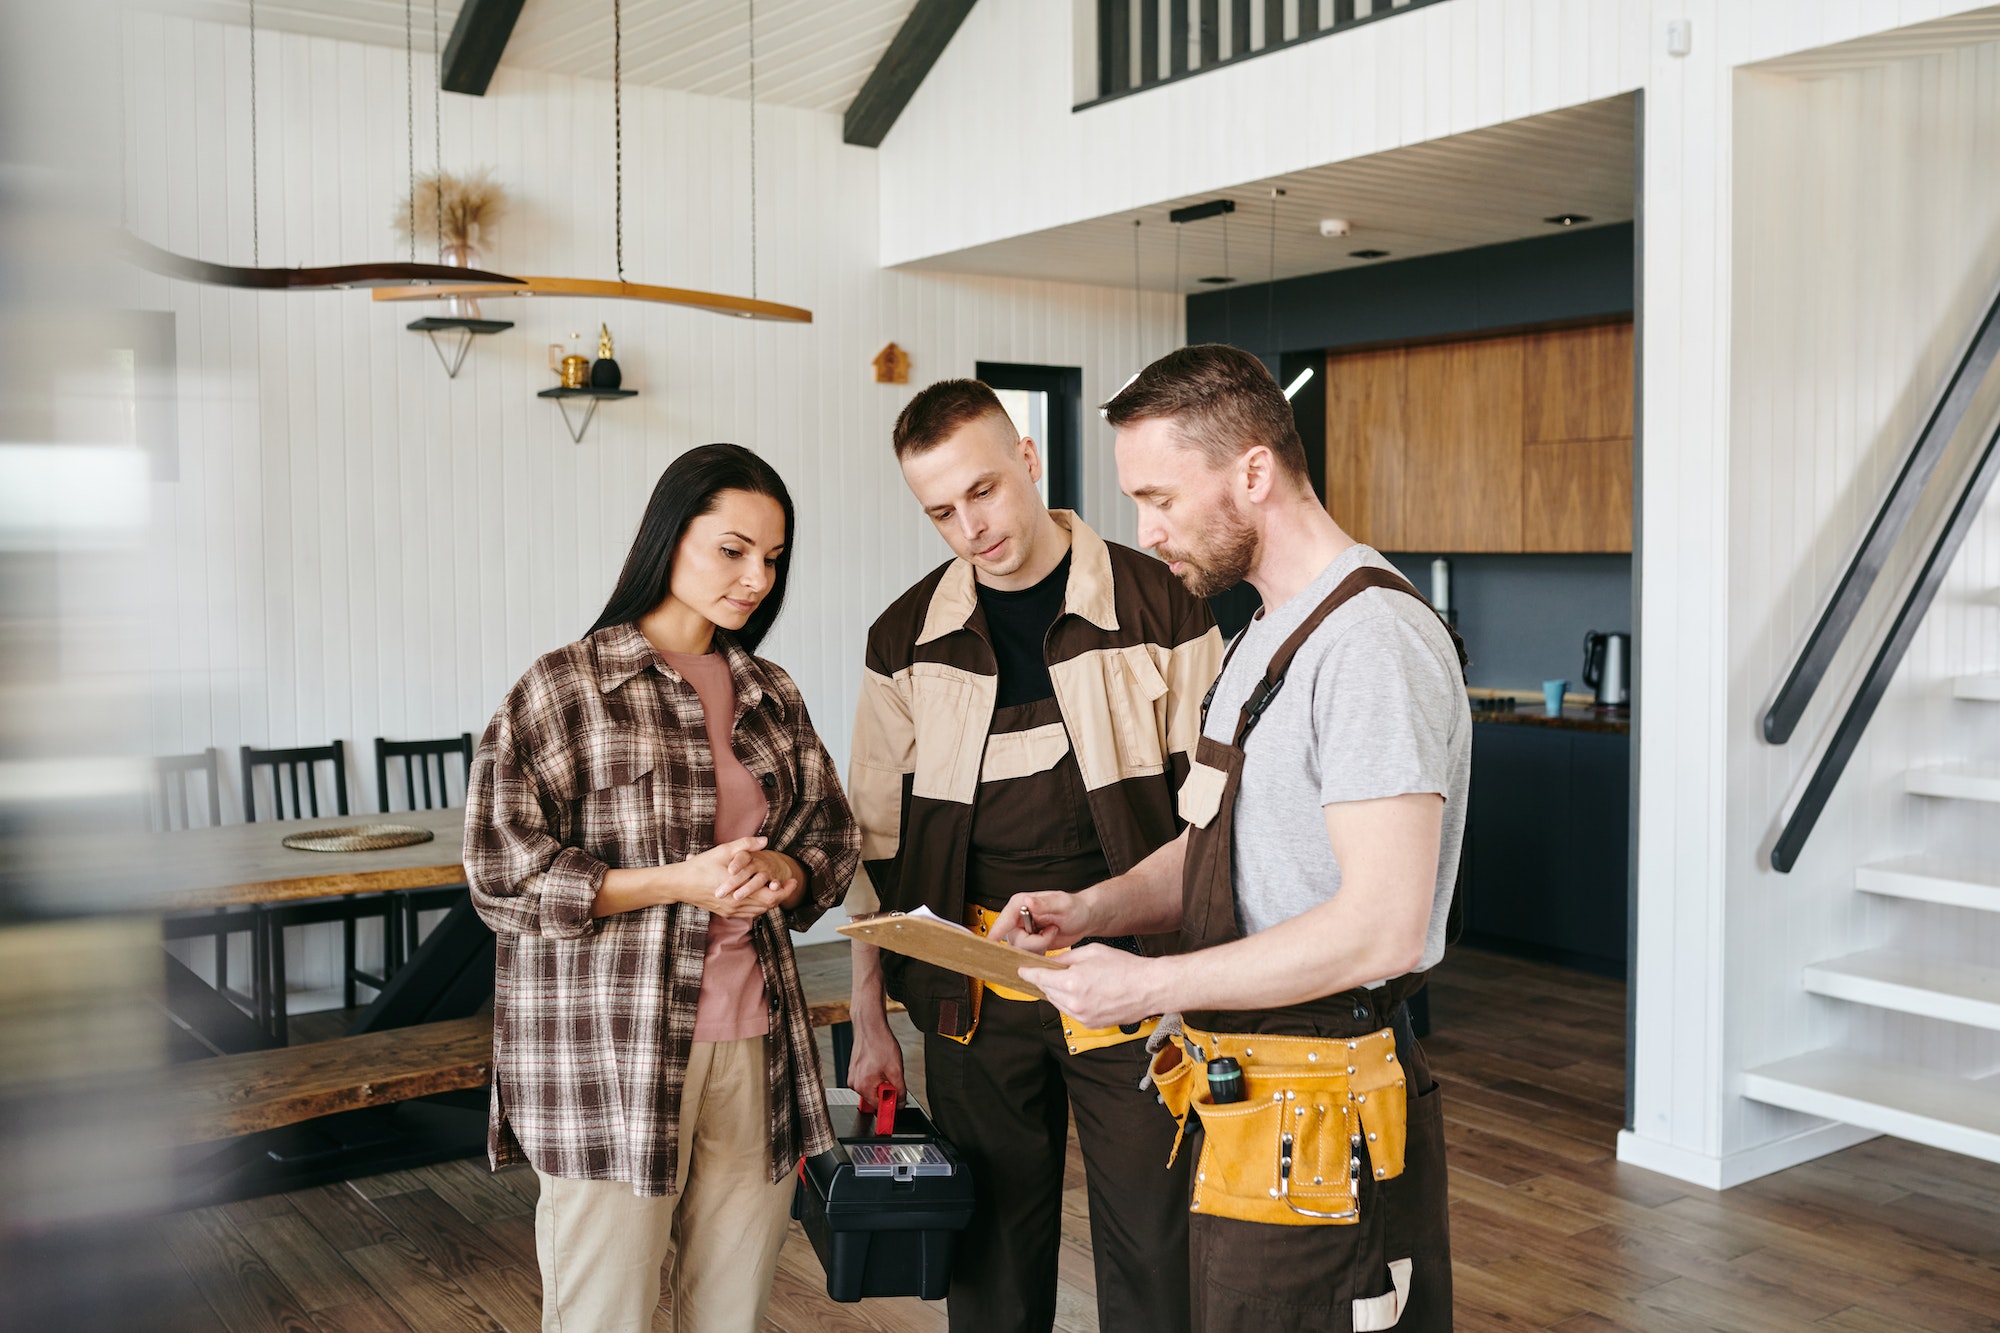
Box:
[126,12,1180,996]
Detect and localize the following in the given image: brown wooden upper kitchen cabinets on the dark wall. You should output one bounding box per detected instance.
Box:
[1326,322,1632,554]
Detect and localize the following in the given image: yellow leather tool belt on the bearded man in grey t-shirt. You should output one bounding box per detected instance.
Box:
[1152,1029,1408,1227]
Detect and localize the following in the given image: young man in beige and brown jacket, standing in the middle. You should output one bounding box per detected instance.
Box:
[848,380,1222,1333]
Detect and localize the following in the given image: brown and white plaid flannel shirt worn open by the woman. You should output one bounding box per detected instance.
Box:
[466,624,860,1195]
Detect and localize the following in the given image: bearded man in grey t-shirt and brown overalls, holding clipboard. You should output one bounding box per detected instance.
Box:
[1002,346,1472,1333]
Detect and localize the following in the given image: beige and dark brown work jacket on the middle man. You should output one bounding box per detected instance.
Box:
[848,510,1222,1037]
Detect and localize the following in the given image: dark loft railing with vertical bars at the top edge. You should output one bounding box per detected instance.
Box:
[1078,0,1442,110]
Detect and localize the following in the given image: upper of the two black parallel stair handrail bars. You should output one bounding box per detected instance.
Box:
[1764,276,2000,745]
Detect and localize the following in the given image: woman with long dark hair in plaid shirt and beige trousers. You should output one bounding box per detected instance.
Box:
[466,444,860,1333]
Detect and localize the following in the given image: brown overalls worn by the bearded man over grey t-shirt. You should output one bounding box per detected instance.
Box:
[1180,566,1464,1333]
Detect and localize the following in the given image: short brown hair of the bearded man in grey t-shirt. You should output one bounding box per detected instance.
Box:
[1104,342,1312,486]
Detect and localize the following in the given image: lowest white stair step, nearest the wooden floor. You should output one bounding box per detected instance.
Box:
[1744,1051,2000,1161]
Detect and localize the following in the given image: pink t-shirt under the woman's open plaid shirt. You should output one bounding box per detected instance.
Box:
[660,652,770,1041]
